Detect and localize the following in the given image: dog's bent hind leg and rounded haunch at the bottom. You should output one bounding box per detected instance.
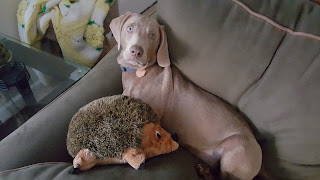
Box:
[219,135,262,180]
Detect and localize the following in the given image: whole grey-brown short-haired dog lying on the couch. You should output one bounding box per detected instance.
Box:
[110,13,262,179]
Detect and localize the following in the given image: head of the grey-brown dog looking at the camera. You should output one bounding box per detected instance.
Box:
[110,13,170,76]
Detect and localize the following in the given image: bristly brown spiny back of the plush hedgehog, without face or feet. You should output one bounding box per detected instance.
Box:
[67,95,159,158]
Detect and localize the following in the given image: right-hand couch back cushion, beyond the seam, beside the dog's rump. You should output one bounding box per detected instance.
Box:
[239,33,320,178]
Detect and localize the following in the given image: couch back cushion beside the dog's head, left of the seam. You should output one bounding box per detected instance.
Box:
[158,0,285,104]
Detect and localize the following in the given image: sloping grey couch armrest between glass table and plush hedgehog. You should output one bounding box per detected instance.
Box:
[0,48,122,171]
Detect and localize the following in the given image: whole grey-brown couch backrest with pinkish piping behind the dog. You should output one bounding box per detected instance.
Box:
[158,0,320,177]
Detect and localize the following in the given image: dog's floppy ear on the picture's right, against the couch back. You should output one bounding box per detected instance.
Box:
[157,25,170,67]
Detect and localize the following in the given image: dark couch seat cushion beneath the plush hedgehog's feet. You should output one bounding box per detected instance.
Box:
[0,149,200,180]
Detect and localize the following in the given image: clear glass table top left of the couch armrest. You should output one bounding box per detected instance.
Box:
[0,33,90,141]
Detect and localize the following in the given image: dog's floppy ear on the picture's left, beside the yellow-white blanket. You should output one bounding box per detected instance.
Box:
[110,12,131,50]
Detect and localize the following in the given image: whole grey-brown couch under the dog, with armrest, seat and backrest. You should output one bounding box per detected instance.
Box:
[0,0,320,179]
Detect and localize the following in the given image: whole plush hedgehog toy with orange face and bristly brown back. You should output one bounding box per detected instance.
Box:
[67,95,179,171]
